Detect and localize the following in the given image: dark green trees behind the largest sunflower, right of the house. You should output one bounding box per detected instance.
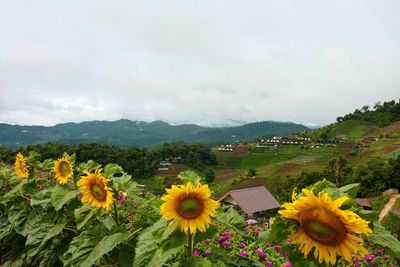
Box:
[269,156,400,201]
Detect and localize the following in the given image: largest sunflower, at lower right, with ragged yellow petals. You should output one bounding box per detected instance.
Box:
[279,189,372,265]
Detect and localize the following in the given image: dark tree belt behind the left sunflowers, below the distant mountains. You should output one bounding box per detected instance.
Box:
[0,142,217,178]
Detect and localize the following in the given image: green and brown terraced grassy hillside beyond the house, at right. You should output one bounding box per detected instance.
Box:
[211,120,400,198]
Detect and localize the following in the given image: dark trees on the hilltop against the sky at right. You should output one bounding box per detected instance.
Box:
[336,100,400,127]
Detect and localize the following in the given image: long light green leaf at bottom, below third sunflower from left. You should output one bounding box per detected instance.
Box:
[82,233,129,266]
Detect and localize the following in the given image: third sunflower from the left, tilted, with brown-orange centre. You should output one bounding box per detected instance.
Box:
[77,169,114,211]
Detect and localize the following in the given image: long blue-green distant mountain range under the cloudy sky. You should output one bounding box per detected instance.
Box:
[0,119,309,148]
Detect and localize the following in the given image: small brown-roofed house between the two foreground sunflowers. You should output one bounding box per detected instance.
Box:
[219,186,281,225]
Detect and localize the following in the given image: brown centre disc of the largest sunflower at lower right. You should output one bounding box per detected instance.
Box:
[301,212,346,246]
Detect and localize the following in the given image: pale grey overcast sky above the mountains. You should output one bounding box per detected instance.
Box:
[0,0,400,125]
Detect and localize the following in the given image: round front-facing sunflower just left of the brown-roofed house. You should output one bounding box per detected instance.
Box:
[160,182,218,234]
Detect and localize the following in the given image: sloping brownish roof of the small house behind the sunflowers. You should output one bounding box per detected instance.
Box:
[221,186,281,217]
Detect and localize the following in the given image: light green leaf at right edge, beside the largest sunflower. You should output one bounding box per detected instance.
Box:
[367,223,400,259]
